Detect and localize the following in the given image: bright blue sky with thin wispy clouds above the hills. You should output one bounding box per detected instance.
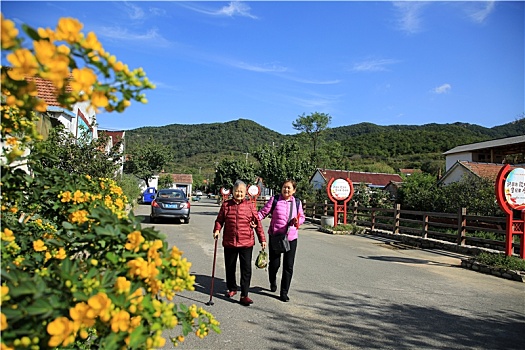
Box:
[1,1,525,134]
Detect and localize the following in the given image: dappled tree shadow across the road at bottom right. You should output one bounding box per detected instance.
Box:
[270,290,525,349]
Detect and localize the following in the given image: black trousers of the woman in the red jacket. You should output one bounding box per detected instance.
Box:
[224,247,253,297]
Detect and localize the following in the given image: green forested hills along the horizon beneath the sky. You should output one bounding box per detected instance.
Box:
[126,118,525,174]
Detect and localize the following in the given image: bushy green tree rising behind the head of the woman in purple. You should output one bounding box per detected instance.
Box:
[253,141,315,191]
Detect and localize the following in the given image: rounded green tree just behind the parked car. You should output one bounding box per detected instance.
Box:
[124,138,171,187]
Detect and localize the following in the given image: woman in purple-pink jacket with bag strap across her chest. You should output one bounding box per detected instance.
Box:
[258,179,305,302]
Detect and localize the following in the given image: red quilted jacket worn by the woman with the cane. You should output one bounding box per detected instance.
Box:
[213,199,266,248]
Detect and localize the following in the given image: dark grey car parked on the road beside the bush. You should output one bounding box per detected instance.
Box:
[150,188,190,224]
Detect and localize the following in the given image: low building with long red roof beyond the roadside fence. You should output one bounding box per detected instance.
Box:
[310,168,403,189]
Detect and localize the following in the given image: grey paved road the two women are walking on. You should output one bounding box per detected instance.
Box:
[135,199,525,349]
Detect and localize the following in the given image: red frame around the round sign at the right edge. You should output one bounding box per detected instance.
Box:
[494,164,525,259]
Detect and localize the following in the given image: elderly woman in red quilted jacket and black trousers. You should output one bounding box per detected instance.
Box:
[213,181,266,306]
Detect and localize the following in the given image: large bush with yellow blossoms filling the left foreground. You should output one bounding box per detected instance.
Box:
[0,15,220,350]
